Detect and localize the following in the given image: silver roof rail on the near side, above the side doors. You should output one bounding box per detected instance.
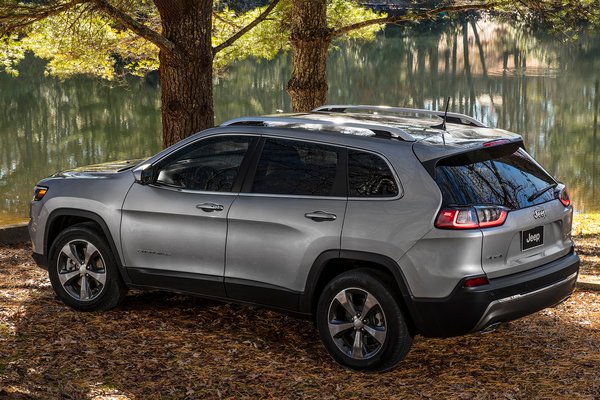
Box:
[221,117,416,142]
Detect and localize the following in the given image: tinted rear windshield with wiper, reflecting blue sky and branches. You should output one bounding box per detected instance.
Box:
[435,146,556,210]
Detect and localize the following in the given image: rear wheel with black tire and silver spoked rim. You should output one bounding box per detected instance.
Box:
[316,269,412,371]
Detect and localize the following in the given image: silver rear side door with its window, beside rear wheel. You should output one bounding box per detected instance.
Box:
[225,137,346,309]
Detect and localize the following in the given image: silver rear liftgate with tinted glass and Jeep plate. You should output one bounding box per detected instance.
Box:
[436,146,573,278]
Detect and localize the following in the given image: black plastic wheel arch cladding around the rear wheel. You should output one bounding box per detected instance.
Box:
[299,250,415,332]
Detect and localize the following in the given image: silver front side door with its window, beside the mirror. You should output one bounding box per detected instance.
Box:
[121,135,258,296]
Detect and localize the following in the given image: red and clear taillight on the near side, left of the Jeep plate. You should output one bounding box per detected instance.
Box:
[435,207,508,229]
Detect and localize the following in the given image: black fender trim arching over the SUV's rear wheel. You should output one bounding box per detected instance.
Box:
[299,250,412,314]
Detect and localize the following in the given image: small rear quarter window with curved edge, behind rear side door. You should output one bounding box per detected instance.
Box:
[348,150,398,197]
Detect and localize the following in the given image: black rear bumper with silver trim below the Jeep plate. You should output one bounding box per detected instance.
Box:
[409,252,579,337]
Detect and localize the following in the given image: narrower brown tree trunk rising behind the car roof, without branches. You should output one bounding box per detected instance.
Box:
[287,0,331,112]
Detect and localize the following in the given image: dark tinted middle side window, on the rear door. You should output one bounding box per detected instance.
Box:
[252,138,344,196]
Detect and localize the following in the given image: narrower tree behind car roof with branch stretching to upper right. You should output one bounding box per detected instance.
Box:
[287,0,600,112]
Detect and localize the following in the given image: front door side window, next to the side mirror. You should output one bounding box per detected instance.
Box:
[156,136,254,192]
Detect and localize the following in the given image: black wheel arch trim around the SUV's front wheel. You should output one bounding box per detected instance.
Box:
[44,208,130,283]
